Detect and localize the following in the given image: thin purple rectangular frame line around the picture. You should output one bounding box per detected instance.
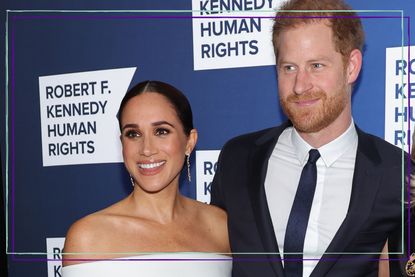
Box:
[11,11,411,262]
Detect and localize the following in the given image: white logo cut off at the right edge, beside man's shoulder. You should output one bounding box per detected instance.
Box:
[385,46,415,147]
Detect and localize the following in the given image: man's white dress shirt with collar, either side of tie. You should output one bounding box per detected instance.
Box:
[265,120,358,277]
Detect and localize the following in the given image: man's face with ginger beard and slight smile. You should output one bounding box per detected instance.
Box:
[277,21,354,133]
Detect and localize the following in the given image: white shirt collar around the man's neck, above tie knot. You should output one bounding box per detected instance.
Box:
[291,119,358,167]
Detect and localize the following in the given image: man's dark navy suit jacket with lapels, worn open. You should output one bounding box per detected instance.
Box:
[211,122,406,277]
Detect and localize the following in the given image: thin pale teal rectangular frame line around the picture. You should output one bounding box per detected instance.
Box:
[5,9,411,260]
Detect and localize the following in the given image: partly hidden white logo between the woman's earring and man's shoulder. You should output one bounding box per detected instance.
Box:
[196,150,220,203]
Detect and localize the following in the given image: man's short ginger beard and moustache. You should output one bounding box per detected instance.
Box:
[280,86,348,133]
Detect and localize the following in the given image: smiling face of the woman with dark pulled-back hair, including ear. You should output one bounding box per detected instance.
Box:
[121,92,197,192]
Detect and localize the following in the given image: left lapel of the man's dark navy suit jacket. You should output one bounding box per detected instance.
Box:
[248,122,290,276]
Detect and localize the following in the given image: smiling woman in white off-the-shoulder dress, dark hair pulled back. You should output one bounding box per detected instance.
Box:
[63,81,231,277]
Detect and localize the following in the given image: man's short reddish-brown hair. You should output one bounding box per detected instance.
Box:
[272,0,365,62]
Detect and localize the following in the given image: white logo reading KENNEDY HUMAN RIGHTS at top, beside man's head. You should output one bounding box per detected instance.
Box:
[192,0,284,70]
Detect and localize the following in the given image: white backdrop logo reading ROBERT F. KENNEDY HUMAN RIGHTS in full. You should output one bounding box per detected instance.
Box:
[39,67,136,166]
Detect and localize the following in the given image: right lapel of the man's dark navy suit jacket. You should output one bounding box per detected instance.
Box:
[311,127,381,276]
